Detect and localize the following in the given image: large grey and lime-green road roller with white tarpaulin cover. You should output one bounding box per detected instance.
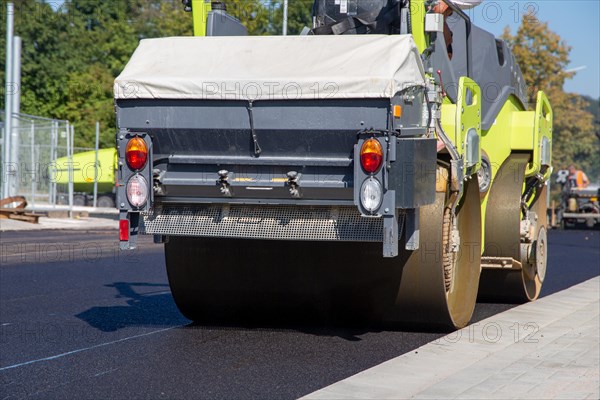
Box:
[115,0,552,327]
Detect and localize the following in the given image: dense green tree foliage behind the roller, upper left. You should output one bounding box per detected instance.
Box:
[0,0,312,147]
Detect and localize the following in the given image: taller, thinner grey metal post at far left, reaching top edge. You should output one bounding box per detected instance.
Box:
[2,3,14,198]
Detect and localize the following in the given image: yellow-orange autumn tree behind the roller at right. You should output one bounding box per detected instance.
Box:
[503,15,600,180]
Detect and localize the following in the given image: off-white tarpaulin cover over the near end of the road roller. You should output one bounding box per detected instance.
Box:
[114,35,425,100]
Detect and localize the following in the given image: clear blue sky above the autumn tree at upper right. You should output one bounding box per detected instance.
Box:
[51,0,600,98]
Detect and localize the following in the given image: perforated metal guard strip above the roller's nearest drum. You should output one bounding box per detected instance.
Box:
[140,204,383,242]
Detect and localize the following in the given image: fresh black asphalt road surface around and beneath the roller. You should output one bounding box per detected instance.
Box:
[0,230,600,399]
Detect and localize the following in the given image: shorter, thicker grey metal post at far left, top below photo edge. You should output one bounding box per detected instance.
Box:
[10,36,21,194]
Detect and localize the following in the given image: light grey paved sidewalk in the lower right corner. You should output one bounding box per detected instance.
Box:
[304,277,600,400]
